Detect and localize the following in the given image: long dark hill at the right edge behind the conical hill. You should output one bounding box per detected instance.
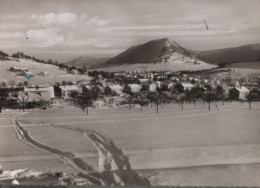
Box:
[195,44,260,65]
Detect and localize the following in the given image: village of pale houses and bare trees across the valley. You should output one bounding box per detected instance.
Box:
[0,64,260,113]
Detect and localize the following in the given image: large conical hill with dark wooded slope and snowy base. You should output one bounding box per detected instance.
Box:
[99,38,215,71]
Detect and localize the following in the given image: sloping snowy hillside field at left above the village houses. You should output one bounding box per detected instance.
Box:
[0,59,90,84]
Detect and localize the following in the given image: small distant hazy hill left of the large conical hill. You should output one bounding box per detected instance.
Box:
[64,56,109,69]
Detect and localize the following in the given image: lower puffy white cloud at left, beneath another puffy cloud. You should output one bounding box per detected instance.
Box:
[26,28,64,47]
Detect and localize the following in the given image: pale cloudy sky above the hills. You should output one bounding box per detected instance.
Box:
[0,0,260,62]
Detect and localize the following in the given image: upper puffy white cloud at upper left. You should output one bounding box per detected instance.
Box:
[37,13,77,25]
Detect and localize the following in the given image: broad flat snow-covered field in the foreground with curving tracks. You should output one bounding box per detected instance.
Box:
[0,102,260,186]
